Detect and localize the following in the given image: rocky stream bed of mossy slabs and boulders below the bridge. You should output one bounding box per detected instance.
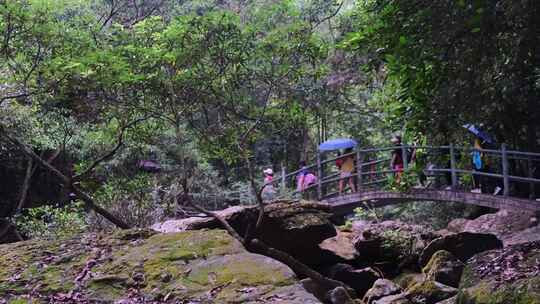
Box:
[0,203,540,304]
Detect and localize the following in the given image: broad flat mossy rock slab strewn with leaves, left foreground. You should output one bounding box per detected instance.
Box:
[0,230,320,304]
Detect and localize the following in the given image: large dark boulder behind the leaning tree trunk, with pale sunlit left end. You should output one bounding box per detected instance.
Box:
[152,202,343,264]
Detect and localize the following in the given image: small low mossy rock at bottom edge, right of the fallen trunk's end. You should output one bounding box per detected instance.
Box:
[406,280,458,304]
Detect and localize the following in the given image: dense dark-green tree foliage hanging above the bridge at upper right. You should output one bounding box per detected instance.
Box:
[344,0,540,151]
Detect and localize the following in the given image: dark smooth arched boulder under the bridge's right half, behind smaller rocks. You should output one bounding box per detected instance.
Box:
[419,232,503,266]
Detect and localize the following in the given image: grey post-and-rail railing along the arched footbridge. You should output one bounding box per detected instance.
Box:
[273,145,540,199]
